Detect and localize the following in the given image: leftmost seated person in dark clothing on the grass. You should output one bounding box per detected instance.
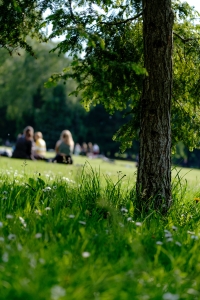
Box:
[12,126,34,160]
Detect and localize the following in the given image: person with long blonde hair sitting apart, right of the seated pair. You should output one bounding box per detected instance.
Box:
[52,130,74,164]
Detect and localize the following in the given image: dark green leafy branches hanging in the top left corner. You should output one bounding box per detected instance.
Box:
[0,0,43,55]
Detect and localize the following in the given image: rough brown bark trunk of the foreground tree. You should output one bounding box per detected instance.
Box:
[137,0,173,212]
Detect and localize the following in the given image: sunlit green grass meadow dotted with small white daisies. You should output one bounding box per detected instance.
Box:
[0,156,200,300]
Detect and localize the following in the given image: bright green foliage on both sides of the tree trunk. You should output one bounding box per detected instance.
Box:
[43,0,200,149]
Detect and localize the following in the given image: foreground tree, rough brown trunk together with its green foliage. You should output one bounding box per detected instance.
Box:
[43,0,199,211]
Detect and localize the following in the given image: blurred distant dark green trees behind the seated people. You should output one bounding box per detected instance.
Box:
[0,43,138,158]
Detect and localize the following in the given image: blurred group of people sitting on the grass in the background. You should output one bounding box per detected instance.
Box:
[6,126,100,164]
